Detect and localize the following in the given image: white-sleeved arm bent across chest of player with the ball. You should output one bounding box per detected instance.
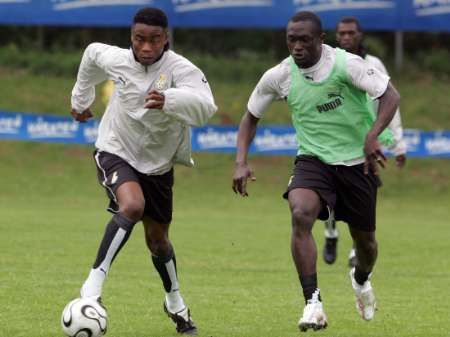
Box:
[145,65,217,126]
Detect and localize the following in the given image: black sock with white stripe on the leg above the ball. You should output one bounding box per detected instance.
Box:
[93,213,136,268]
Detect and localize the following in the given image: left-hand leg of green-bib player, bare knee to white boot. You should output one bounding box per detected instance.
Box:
[288,188,327,331]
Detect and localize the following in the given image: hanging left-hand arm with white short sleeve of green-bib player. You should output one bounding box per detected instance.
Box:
[232,66,282,197]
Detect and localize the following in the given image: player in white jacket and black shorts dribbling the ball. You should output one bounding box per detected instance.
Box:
[71,8,217,334]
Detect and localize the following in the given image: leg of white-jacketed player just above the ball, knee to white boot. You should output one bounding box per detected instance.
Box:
[80,181,145,298]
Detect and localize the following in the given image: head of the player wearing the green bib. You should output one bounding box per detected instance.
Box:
[286,21,324,68]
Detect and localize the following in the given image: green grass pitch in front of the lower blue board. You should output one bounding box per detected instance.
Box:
[0,142,450,337]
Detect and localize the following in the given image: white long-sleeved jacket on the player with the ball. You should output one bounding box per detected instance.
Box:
[71,43,217,174]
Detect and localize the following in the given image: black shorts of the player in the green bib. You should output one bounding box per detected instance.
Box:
[283,155,381,232]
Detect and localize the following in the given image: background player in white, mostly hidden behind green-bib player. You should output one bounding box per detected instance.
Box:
[322,16,406,267]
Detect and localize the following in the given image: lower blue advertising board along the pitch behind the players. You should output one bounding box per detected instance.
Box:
[0,111,450,158]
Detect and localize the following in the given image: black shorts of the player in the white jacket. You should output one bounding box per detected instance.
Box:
[94,151,173,224]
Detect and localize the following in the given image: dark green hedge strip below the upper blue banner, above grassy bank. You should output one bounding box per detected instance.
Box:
[0,43,450,79]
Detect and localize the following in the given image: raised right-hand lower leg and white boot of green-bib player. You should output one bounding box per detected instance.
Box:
[350,228,378,320]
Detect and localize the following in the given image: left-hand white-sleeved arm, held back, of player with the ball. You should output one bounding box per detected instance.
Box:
[70,43,114,122]
